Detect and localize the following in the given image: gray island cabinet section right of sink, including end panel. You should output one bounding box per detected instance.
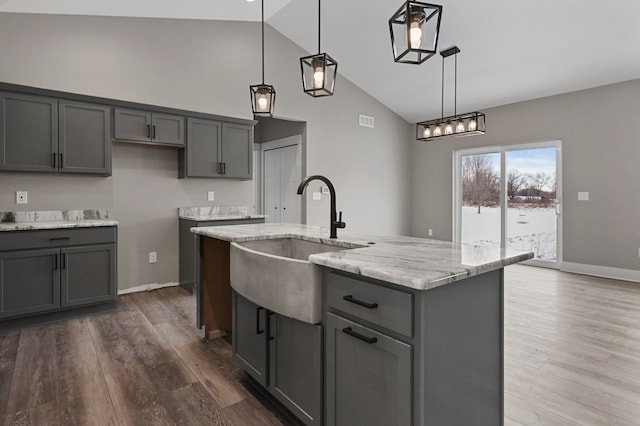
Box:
[323,269,504,426]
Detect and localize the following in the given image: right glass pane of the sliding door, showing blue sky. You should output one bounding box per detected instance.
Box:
[505,147,559,262]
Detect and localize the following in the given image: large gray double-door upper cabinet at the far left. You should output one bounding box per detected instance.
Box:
[0,92,111,176]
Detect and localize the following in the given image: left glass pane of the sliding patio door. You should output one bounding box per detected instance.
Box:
[459,152,502,247]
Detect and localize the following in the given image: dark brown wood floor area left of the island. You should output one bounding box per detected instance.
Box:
[0,287,292,425]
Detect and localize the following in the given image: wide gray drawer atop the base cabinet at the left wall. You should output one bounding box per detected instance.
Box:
[0,226,116,251]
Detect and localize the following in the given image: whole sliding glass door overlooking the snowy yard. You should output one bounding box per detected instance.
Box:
[454,141,562,267]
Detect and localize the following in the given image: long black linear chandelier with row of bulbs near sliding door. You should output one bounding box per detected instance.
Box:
[416,46,487,141]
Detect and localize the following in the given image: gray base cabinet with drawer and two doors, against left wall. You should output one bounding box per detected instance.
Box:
[0,227,117,319]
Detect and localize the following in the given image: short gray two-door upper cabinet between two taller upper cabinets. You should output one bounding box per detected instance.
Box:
[114,108,184,147]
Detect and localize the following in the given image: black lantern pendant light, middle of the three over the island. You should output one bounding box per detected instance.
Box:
[300,0,338,98]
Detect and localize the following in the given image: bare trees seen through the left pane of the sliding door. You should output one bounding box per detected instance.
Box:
[462,154,500,214]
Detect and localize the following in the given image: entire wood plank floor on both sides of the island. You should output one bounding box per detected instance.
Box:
[0,265,640,426]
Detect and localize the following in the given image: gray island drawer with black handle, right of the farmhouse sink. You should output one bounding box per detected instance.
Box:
[325,272,413,337]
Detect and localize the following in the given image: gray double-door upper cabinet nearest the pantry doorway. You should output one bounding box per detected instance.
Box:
[179,118,253,180]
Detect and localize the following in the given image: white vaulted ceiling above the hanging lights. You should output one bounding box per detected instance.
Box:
[5,0,640,122]
